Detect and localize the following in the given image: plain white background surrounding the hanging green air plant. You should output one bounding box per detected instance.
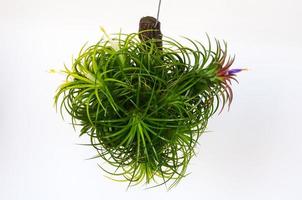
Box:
[0,0,302,200]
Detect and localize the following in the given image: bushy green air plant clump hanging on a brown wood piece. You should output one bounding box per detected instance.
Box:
[55,17,243,188]
